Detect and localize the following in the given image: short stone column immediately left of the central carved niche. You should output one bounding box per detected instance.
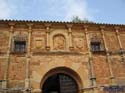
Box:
[45,24,51,50]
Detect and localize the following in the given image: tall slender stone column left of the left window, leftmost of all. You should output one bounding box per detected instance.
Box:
[2,23,15,89]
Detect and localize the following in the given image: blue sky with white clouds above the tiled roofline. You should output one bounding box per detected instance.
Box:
[0,0,125,24]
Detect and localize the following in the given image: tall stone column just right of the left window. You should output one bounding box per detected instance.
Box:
[25,24,33,93]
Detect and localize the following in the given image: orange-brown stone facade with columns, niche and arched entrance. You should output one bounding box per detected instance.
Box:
[0,20,125,93]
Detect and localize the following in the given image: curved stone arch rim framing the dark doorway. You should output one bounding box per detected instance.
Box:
[40,66,83,93]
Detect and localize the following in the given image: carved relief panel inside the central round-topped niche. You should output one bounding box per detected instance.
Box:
[53,34,66,50]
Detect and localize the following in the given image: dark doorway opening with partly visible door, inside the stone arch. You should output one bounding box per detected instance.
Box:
[42,73,78,93]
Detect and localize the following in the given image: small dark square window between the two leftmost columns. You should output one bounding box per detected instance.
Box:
[14,41,26,53]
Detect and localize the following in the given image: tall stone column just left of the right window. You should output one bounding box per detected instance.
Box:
[84,26,97,90]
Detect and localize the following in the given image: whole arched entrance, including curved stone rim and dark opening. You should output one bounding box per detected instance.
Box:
[40,67,82,93]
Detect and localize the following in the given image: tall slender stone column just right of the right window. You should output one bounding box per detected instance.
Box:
[100,26,115,84]
